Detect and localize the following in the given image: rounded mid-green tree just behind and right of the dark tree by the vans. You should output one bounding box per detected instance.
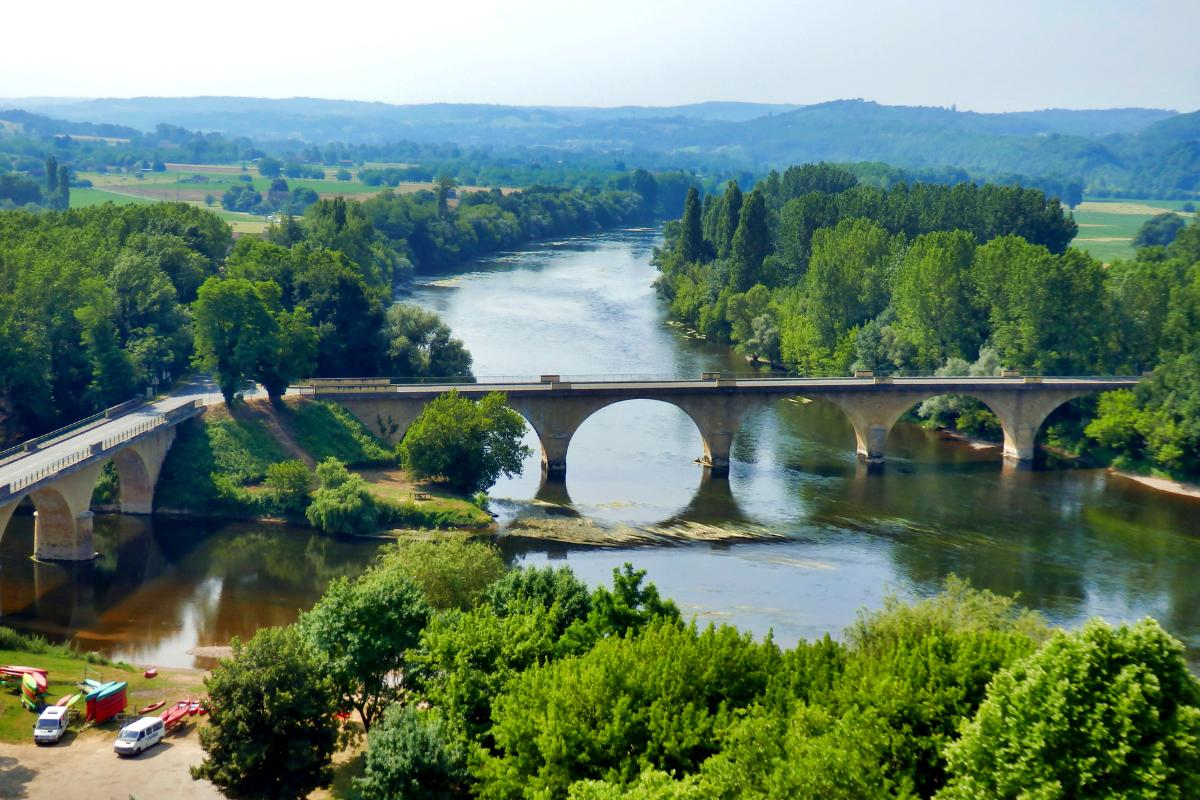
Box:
[299,567,432,733]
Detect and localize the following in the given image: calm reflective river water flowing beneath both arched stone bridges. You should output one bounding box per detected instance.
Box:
[0,230,1200,668]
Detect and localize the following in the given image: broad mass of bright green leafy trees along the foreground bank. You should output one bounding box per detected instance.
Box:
[193,539,1200,800]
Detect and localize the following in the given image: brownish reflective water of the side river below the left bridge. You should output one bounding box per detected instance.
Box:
[0,515,378,667]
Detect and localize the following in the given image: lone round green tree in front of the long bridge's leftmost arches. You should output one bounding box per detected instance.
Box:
[398,390,533,494]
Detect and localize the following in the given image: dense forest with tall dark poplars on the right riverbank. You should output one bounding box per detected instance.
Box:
[655,159,1200,477]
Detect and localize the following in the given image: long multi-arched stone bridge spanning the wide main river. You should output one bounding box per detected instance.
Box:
[300,373,1139,476]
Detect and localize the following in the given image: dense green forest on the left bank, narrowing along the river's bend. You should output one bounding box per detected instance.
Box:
[0,173,656,443]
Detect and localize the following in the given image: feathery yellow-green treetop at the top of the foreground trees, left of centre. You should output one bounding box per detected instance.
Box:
[383,536,504,609]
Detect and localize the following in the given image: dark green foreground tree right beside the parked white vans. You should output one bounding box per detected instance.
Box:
[192,627,337,800]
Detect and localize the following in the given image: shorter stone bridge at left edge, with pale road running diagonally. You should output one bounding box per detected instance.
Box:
[0,397,203,561]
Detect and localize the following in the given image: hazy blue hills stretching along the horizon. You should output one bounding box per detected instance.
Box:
[7,96,1200,198]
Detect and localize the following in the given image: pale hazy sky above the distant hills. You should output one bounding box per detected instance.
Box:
[0,0,1200,112]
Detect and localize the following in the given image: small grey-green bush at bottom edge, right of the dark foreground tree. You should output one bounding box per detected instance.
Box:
[354,705,467,800]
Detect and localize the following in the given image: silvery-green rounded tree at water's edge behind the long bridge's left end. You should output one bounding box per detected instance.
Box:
[384,302,470,378]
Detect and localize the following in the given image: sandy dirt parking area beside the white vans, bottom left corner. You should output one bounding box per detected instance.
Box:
[0,724,222,800]
